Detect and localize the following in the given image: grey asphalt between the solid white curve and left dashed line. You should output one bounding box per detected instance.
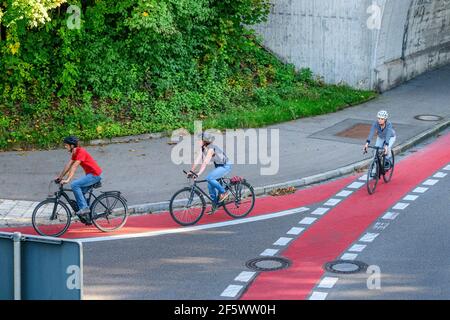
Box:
[84,205,312,300]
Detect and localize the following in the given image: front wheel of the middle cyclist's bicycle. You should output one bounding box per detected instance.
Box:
[169,187,206,226]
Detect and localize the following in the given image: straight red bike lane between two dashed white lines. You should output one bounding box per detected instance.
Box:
[241,134,450,300]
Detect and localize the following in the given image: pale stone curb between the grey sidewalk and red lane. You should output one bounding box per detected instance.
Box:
[129,120,450,214]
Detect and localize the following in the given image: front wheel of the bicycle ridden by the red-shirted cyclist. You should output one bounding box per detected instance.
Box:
[31,199,71,237]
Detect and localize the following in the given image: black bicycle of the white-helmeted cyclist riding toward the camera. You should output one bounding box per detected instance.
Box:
[365,146,395,194]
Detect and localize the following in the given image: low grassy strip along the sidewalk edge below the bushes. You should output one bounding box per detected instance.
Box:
[0,82,376,151]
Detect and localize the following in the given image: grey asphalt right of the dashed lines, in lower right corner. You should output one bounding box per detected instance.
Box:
[327,165,450,300]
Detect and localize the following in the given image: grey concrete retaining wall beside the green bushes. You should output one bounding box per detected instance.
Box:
[255,0,450,91]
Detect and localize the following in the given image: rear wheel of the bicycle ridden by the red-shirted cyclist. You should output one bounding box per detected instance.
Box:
[91,193,128,232]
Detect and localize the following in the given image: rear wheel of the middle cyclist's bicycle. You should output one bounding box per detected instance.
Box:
[223,181,256,218]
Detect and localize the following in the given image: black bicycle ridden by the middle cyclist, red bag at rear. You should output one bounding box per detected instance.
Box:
[169,170,256,226]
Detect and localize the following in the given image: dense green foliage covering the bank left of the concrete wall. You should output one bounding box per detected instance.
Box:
[0,0,372,149]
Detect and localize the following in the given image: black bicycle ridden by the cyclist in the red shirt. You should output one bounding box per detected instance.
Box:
[32,181,128,237]
